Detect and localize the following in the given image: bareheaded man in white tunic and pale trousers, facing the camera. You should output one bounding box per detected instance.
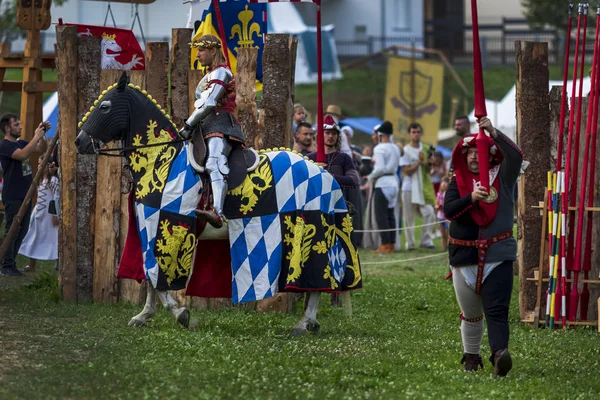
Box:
[400,123,435,250]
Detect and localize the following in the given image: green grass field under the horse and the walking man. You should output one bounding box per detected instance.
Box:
[0,250,600,399]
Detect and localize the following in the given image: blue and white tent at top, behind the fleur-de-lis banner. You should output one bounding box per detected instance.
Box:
[187,0,342,83]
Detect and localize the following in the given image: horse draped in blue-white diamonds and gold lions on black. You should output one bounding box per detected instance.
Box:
[76,73,362,334]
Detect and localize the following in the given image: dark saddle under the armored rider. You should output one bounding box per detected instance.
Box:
[186,129,259,190]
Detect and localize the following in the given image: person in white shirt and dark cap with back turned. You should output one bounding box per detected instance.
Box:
[367,121,400,253]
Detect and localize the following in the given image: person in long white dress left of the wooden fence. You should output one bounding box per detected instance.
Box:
[19,163,58,264]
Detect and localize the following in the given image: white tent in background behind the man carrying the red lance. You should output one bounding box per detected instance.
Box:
[438,77,591,140]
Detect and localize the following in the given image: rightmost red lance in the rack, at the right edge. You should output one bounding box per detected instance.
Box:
[579,5,600,321]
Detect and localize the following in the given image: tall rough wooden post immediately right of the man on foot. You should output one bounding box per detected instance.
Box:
[515,42,553,319]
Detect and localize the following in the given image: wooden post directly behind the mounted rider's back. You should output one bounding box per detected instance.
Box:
[235,48,258,146]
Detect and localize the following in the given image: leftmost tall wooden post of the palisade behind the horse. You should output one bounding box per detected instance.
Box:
[56,25,79,301]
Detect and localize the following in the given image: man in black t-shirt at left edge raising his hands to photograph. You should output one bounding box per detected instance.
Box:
[0,114,50,276]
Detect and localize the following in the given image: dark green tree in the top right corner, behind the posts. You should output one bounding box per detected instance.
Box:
[521,0,580,32]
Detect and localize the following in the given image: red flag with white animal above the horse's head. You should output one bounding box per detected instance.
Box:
[65,24,145,71]
